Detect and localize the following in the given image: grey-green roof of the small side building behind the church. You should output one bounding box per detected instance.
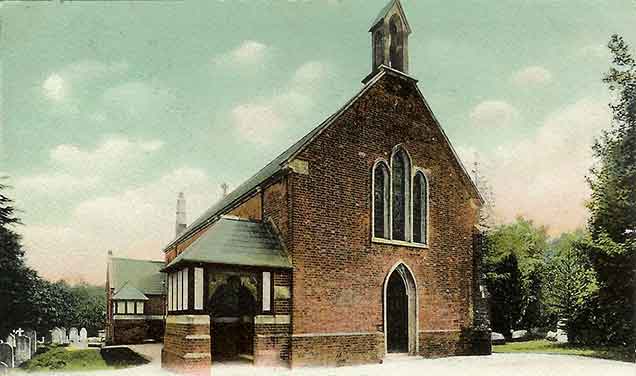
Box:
[108,257,165,295]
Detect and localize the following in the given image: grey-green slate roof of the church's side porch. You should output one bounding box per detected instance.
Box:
[164,217,292,270]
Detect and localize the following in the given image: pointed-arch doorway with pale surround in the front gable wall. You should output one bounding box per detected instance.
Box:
[384,263,417,355]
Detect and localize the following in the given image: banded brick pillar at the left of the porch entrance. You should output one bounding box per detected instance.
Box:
[161,315,212,375]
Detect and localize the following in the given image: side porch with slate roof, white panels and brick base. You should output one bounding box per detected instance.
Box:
[162,218,292,372]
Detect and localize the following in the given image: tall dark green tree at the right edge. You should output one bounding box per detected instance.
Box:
[586,35,636,346]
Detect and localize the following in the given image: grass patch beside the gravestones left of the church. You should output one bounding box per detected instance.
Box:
[20,346,148,372]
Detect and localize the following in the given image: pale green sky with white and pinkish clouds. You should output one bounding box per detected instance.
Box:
[0,0,636,283]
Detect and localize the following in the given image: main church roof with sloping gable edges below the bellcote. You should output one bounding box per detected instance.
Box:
[163,65,484,252]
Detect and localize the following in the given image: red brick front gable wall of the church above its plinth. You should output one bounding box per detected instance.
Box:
[286,71,477,358]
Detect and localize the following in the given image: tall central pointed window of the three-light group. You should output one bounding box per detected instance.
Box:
[391,148,411,241]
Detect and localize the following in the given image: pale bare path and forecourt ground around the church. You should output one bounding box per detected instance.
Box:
[18,345,636,376]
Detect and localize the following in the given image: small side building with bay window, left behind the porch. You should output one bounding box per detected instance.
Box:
[106,253,166,345]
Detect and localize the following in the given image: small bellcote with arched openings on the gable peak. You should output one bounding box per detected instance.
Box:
[369,0,411,74]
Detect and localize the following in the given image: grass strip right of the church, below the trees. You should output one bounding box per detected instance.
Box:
[492,340,635,362]
